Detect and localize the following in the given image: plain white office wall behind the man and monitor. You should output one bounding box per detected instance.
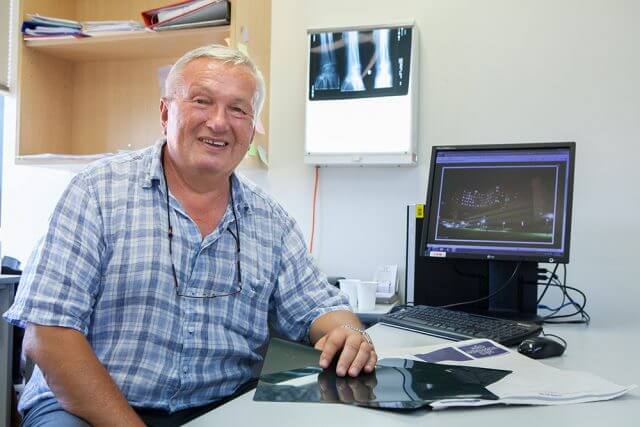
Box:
[0,0,640,322]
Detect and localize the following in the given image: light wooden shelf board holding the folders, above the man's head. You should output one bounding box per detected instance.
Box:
[24,25,230,62]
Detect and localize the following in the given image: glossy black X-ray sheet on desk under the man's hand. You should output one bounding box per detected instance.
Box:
[254,339,511,410]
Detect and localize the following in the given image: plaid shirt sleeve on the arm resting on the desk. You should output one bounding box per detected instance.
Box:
[270,218,350,342]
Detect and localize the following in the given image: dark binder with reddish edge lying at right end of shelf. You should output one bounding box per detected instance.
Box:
[142,0,231,31]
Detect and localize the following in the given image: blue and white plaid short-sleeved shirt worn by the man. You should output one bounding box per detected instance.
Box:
[4,141,349,412]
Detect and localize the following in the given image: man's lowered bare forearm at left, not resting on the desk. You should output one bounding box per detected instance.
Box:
[24,324,144,426]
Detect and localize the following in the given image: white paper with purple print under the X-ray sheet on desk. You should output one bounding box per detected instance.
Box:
[379,339,637,409]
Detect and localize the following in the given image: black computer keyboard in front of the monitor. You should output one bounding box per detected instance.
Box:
[380,305,542,346]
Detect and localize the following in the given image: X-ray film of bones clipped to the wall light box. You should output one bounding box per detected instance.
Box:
[309,27,412,101]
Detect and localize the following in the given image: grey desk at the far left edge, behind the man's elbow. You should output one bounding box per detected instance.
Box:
[0,274,20,426]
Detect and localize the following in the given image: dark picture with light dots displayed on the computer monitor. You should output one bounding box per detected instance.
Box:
[436,166,558,244]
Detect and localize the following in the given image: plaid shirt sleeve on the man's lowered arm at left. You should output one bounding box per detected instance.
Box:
[4,174,105,335]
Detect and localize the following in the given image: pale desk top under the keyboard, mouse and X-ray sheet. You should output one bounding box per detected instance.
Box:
[188,324,640,427]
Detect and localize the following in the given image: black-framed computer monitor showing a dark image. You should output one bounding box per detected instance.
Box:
[422,143,575,262]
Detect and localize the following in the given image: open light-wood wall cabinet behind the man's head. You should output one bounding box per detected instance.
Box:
[16,0,271,165]
